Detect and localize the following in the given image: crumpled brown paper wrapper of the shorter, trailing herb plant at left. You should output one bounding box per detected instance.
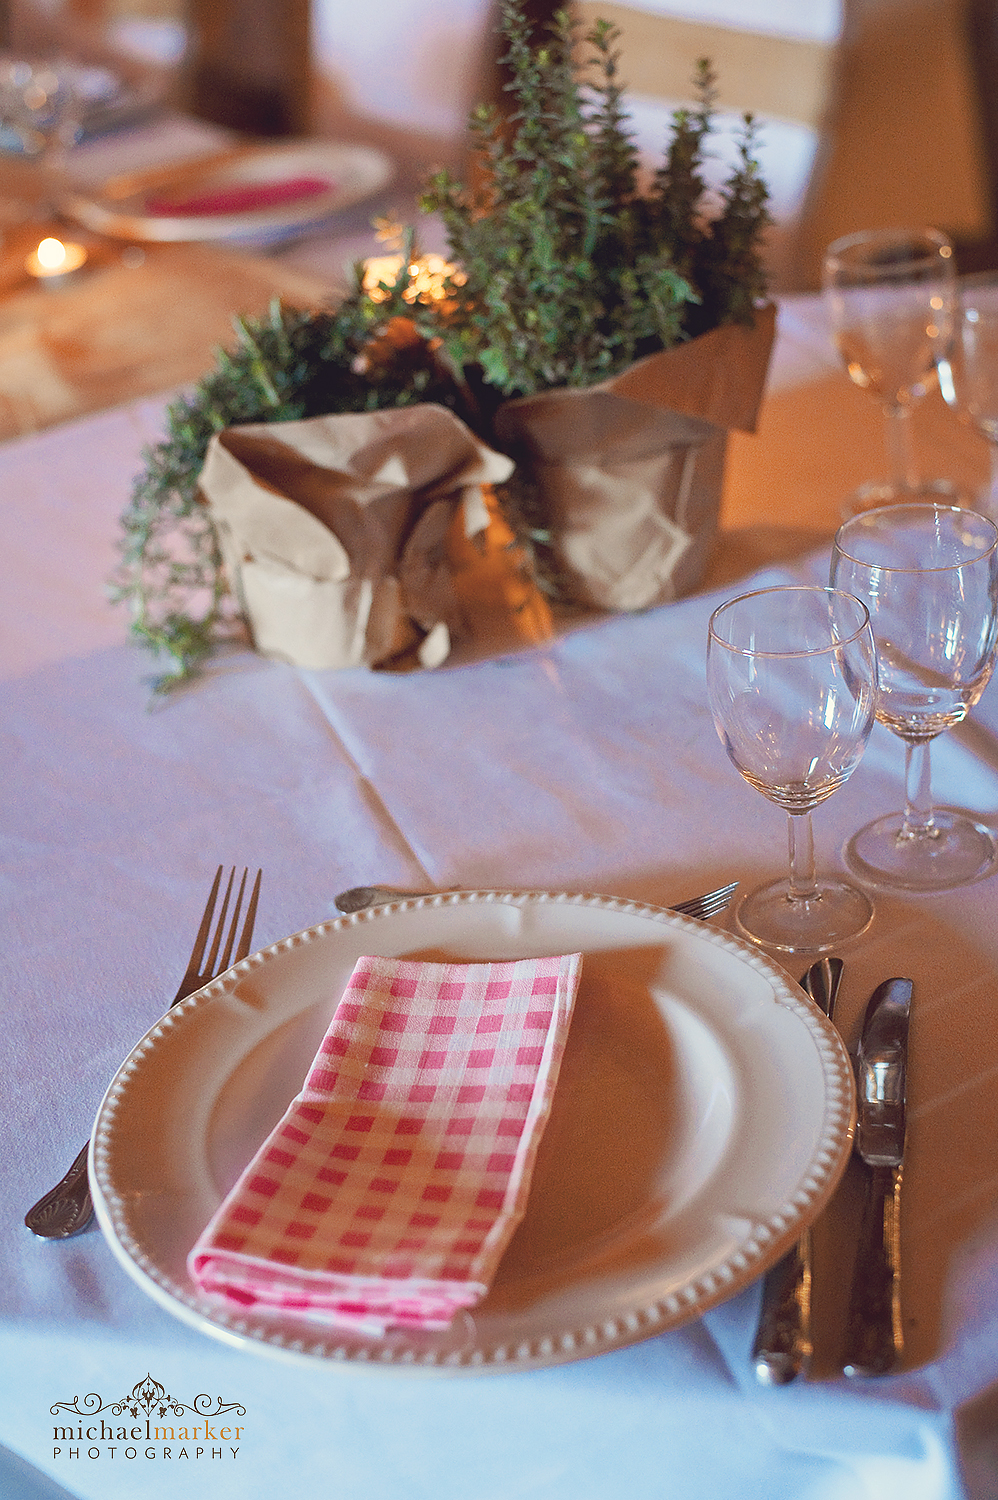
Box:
[200,402,513,668]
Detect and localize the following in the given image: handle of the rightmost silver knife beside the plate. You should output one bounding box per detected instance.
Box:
[843,1167,905,1376]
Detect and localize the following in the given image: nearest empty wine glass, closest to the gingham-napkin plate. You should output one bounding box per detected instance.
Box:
[707,588,876,953]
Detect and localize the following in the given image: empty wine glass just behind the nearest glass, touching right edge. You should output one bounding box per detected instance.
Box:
[831,503,998,891]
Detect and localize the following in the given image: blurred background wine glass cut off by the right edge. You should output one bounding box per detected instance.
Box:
[939,275,998,521]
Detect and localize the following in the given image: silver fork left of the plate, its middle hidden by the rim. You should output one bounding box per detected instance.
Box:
[24,864,263,1239]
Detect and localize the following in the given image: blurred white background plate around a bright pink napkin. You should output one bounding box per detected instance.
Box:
[60,141,392,243]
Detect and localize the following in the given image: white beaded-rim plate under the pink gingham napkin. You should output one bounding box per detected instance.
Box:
[90,891,854,1373]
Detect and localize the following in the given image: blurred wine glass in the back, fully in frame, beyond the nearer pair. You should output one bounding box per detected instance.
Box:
[822,230,957,515]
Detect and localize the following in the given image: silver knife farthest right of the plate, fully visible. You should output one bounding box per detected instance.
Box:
[842,980,912,1376]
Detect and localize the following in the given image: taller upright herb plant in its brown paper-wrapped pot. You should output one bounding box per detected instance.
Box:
[423,10,773,609]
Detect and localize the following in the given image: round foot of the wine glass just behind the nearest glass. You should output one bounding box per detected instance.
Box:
[842,807,998,891]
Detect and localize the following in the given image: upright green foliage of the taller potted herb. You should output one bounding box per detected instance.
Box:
[423,0,768,396]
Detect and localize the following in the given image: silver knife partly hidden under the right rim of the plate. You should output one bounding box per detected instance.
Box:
[752,959,842,1386]
